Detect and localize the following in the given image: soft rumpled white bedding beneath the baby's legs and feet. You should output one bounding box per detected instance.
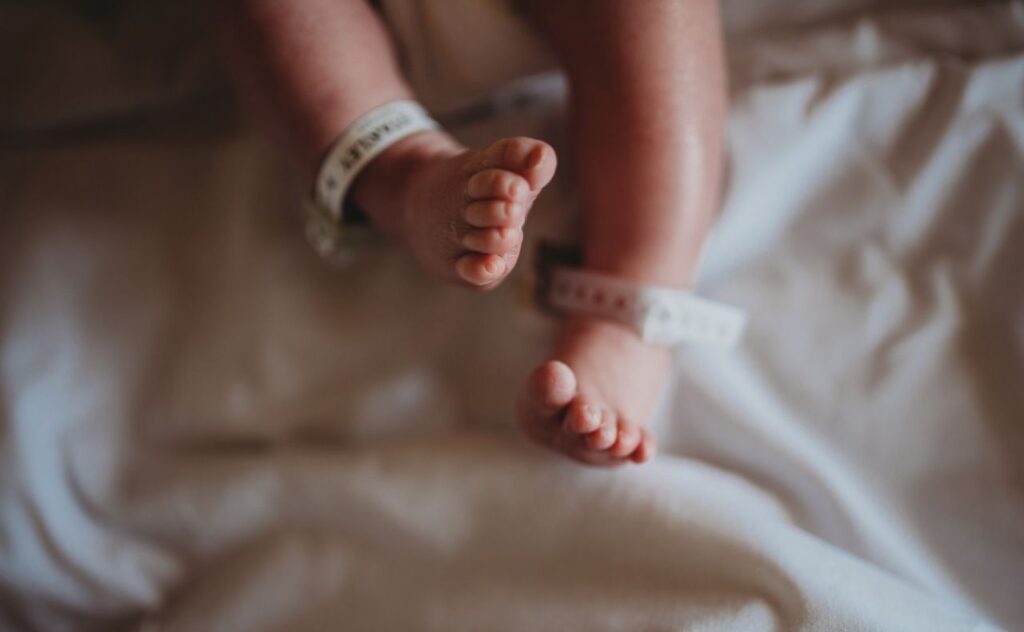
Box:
[0,2,1024,632]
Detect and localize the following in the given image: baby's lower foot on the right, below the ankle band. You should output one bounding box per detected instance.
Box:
[517,318,671,465]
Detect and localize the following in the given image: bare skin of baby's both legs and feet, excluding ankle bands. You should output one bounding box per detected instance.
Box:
[213,0,726,466]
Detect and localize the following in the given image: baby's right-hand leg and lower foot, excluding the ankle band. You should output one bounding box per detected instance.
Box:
[519,0,726,465]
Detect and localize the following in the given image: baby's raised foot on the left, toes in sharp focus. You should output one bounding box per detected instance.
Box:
[352,132,555,289]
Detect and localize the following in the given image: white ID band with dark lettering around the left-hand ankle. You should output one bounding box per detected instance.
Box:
[306,100,439,258]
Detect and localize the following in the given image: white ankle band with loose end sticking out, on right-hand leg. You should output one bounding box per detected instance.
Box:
[547,267,746,348]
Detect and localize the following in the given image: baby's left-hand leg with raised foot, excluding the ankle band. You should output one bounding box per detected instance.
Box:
[208,0,555,288]
